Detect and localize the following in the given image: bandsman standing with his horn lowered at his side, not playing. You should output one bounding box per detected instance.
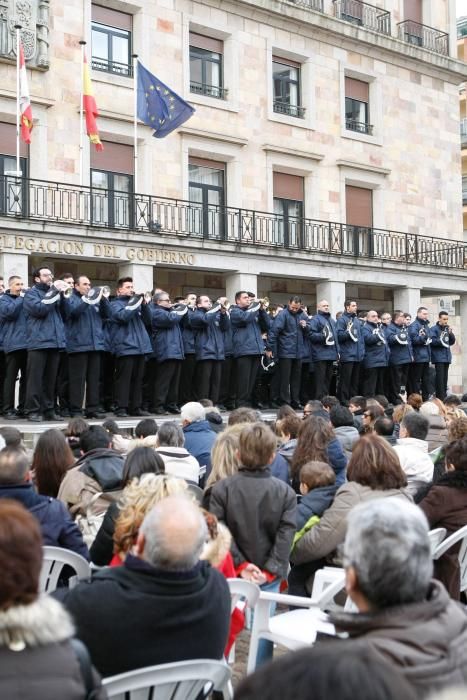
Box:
[266,296,309,409]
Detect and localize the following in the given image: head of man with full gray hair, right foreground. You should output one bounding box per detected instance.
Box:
[344,498,433,609]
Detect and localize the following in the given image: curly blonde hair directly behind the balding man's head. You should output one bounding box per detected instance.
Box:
[113,474,188,558]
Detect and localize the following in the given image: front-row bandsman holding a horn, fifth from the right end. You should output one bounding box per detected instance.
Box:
[336,299,365,405]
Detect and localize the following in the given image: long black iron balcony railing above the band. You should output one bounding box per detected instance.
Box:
[0,175,467,269]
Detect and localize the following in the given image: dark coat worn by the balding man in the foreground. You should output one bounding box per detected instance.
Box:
[53,554,230,676]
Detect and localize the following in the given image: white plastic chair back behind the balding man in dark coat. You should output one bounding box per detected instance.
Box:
[103,659,231,700]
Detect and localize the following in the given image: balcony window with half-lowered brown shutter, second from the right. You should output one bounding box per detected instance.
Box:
[273,173,304,248]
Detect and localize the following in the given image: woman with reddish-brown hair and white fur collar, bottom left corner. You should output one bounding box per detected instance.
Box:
[0,499,107,700]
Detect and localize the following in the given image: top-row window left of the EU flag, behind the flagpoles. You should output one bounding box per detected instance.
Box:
[92,5,133,76]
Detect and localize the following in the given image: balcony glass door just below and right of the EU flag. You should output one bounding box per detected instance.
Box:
[188,158,225,238]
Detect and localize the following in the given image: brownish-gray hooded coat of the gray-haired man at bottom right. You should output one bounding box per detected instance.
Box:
[330,581,467,698]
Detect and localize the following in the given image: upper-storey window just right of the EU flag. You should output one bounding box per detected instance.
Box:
[190,32,227,100]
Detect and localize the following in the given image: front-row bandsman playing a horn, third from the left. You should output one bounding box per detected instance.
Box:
[64,275,110,418]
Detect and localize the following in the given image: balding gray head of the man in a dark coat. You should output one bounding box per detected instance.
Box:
[140,495,208,571]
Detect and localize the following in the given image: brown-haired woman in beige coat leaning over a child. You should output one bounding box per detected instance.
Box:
[289,434,412,595]
